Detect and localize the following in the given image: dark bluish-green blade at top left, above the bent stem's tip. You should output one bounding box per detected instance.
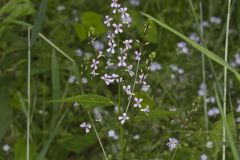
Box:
[31,0,48,46]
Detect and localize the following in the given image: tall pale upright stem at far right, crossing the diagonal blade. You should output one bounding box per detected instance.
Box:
[222,0,231,160]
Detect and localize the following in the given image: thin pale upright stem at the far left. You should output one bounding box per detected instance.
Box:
[26,28,31,160]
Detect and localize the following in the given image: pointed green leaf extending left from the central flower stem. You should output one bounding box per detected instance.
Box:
[51,94,114,108]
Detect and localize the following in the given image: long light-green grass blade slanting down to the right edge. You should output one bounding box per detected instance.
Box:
[142,13,240,82]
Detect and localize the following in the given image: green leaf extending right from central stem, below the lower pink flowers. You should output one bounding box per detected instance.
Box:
[135,109,178,121]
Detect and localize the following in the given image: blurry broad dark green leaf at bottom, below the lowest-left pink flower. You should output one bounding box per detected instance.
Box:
[59,132,97,153]
